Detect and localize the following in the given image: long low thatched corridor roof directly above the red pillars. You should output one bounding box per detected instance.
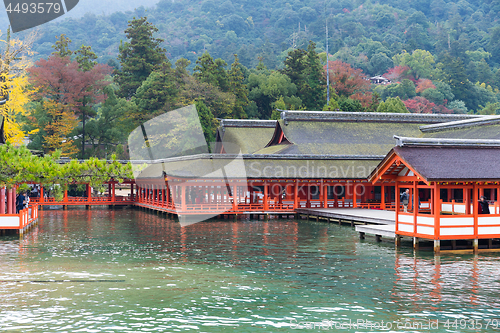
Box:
[136,154,380,179]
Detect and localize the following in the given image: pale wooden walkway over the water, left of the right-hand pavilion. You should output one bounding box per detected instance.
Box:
[297,208,396,240]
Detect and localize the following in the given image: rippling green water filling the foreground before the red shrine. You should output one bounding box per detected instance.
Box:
[0,209,500,332]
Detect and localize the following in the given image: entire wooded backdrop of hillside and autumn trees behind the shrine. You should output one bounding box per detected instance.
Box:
[0,0,500,157]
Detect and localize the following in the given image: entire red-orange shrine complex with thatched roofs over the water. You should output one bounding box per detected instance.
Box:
[0,111,500,251]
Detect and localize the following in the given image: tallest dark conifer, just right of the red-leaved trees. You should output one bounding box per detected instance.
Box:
[115,17,167,98]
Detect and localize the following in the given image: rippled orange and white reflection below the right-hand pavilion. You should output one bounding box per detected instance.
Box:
[391,253,500,312]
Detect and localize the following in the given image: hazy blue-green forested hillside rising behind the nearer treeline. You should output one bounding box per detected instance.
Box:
[24,0,500,70]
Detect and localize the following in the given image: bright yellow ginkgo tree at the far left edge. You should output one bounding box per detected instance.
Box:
[0,28,36,145]
